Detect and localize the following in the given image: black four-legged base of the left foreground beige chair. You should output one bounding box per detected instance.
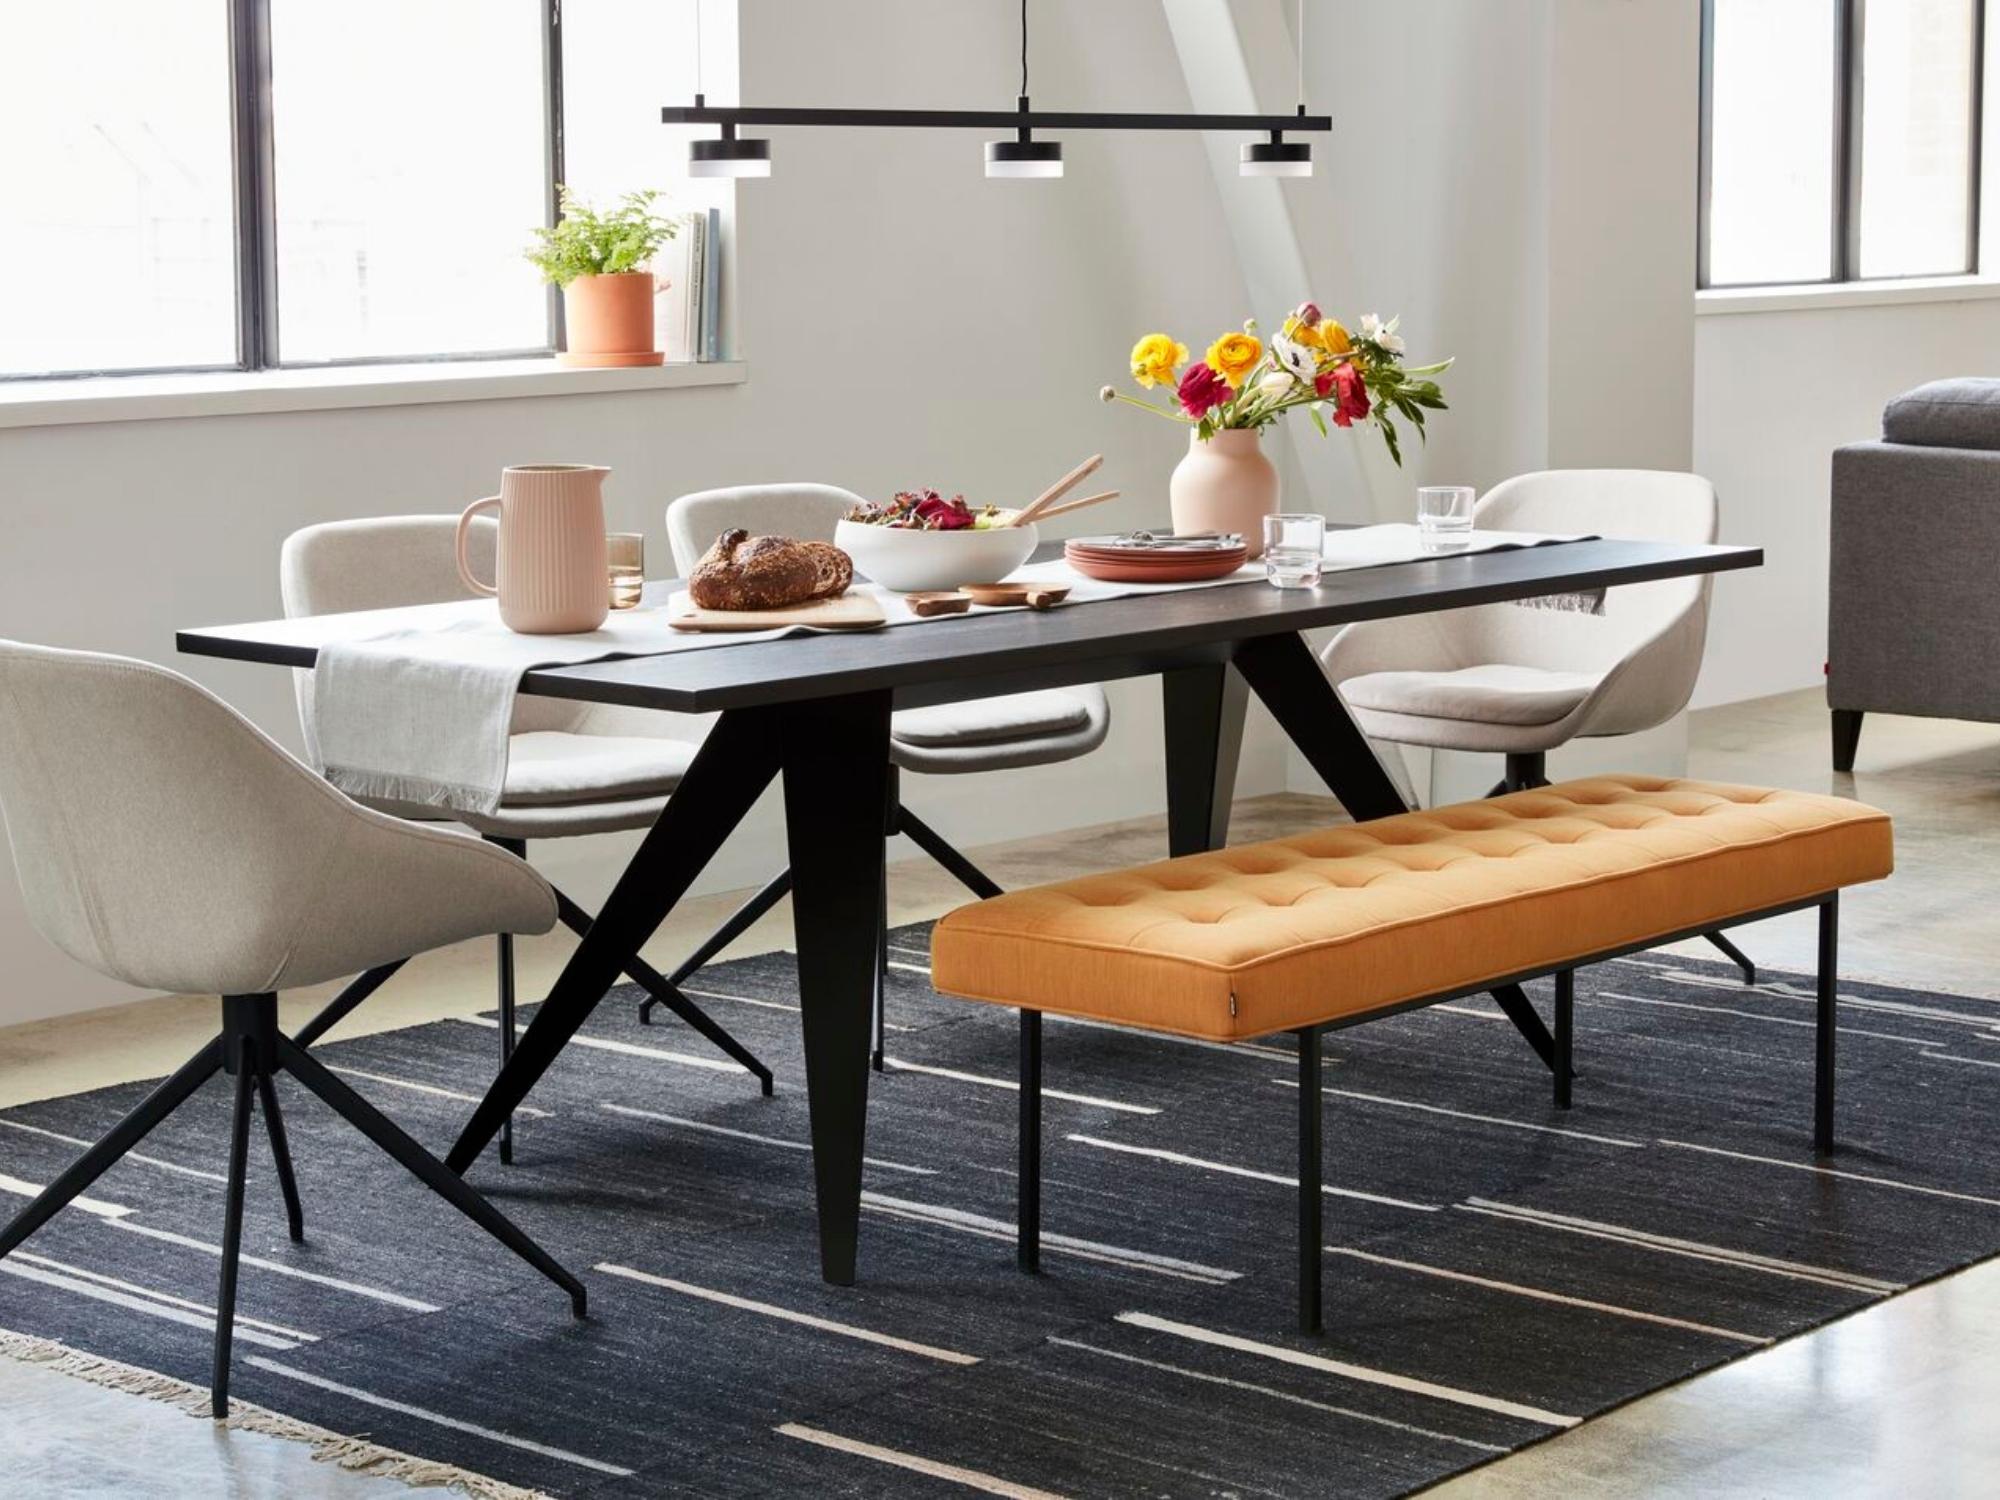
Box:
[0,994,586,1418]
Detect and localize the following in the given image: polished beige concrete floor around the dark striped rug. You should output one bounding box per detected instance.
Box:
[0,692,2000,1500]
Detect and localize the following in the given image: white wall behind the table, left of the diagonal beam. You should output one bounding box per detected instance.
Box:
[0,0,1284,1022]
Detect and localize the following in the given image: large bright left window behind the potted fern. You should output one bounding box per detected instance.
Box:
[0,0,712,380]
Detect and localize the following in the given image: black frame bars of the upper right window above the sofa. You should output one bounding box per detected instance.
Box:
[1694,0,1986,292]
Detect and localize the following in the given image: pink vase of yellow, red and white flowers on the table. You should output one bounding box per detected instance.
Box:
[1098,302,1452,558]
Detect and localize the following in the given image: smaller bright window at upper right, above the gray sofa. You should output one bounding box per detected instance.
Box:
[1700,0,1986,286]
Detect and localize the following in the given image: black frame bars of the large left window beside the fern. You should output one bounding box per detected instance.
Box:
[15,0,564,384]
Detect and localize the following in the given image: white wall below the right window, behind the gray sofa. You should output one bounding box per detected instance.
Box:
[1694,298,2000,706]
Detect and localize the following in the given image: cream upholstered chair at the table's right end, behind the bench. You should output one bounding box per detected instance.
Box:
[1320,468,1756,984]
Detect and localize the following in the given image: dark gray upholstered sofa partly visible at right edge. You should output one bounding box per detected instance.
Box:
[1826,380,2000,770]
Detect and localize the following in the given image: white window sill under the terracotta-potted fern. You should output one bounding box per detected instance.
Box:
[0,358,750,428]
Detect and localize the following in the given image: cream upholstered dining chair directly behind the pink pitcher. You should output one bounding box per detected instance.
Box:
[278,516,772,1162]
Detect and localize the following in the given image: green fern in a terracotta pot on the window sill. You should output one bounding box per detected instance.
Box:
[528,188,674,366]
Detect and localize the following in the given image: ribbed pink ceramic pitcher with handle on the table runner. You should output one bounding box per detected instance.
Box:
[458,464,610,636]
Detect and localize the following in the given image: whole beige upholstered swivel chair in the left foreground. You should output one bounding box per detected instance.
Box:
[0,642,584,1416]
